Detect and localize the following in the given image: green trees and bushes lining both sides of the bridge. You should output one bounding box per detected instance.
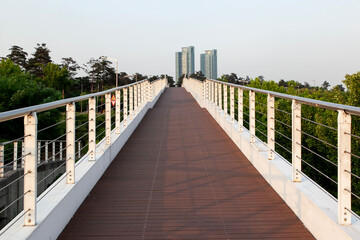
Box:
[0,43,360,213]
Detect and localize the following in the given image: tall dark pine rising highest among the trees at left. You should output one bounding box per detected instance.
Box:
[26,43,51,78]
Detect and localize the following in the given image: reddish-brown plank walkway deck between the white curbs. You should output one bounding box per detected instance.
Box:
[59,88,313,239]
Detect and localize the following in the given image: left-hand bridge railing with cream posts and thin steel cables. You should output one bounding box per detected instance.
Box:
[0,79,167,231]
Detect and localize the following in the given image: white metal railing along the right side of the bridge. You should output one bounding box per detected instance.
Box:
[183,78,360,225]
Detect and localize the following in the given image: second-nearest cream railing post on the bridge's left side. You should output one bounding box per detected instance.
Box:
[65,102,76,184]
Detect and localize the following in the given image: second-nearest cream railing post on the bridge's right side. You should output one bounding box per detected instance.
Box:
[291,100,301,182]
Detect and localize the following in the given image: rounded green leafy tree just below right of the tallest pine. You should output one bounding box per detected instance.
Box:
[43,63,72,99]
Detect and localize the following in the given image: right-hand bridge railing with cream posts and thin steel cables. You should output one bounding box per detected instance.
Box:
[183,79,360,224]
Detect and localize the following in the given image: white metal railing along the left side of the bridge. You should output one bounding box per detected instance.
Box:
[0,78,167,229]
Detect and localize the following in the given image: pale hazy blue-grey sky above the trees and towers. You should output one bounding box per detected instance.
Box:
[0,0,360,86]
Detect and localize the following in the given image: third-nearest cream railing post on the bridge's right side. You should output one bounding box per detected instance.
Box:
[267,94,275,160]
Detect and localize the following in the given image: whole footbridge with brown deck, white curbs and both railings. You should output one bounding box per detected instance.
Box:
[0,79,360,239]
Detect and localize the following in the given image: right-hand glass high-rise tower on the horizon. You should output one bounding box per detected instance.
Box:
[200,49,217,79]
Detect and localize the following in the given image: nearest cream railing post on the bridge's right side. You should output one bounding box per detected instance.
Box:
[338,110,351,225]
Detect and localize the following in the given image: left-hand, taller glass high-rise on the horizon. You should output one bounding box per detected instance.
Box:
[175,46,195,81]
